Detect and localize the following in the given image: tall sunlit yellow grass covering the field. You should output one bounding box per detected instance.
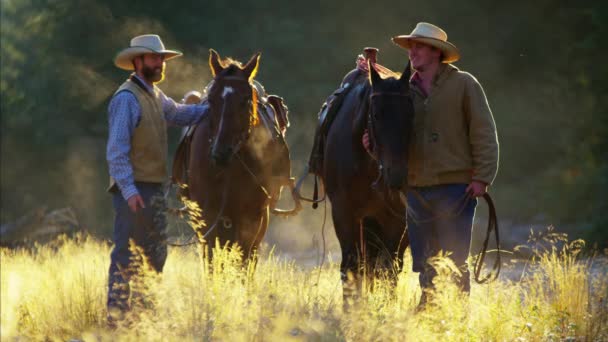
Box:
[0,232,608,341]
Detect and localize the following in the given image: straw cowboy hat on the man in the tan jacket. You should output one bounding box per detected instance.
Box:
[393,23,460,63]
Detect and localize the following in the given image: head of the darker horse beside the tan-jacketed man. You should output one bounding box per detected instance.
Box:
[368,63,414,189]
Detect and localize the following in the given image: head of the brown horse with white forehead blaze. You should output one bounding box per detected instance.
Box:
[208,49,260,166]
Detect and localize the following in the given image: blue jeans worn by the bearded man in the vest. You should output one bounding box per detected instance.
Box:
[107,182,167,313]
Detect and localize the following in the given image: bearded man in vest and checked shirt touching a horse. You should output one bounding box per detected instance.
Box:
[107,34,208,325]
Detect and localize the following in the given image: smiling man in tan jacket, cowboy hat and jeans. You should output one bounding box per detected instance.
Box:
[363,23,498,305]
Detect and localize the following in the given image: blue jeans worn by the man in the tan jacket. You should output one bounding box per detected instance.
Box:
[407,184,477,292]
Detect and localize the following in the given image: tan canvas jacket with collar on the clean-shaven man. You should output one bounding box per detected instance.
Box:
[408,64,498,186]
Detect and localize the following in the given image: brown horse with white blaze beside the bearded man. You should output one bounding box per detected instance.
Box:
[188,50,290,257]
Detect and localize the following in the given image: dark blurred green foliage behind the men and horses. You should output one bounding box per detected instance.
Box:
[0,0,608,244]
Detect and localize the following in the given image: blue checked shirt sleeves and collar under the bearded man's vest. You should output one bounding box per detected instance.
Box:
[106,74,209,200]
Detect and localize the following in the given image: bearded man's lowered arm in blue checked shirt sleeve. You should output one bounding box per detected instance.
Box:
[106,91,141,200]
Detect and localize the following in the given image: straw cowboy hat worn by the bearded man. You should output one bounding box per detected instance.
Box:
[114,34,182,70]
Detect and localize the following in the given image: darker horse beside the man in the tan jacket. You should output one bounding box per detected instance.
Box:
[322,64,414,299]
